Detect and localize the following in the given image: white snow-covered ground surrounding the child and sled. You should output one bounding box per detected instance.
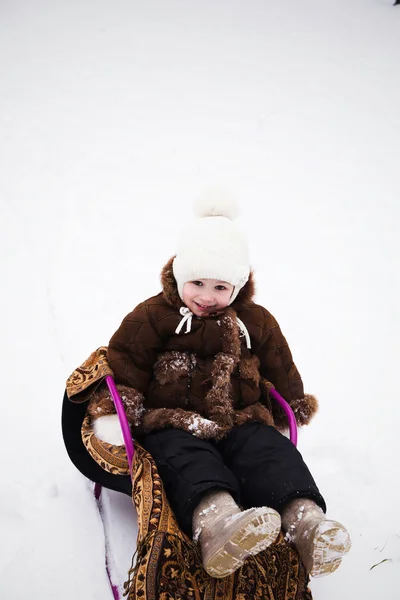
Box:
[0,0,400,600]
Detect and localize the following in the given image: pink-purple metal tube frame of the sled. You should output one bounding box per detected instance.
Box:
[94,375,297,600]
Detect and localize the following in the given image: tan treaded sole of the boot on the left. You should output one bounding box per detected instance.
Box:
[204,507,281,578]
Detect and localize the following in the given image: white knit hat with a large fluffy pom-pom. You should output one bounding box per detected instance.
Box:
[173,191,250,304]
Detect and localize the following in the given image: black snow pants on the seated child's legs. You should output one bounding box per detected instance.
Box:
[139,423,326,537]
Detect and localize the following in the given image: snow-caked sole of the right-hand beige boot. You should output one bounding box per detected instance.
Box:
[307,520,351,578]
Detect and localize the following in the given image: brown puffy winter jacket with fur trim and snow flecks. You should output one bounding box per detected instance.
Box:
[97,259,317,439]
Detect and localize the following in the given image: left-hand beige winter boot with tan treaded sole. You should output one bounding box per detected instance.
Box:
[193,490,281,577]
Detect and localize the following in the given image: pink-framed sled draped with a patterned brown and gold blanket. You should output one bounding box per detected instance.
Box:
[62,347,312,600]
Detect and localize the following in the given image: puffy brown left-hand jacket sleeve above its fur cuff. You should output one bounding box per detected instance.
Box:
[108,303,162,395]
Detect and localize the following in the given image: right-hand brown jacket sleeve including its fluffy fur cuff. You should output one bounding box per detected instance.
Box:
[256,309,318,425]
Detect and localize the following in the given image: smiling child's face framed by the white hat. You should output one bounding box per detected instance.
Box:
[183,279,234,317]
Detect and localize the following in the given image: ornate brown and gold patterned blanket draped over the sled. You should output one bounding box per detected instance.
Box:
[67,347,312,600]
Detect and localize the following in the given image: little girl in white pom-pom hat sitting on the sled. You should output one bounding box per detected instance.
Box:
[90,197,350,577]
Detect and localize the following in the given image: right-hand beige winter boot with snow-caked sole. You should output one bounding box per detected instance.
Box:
[282,499,351,577]
